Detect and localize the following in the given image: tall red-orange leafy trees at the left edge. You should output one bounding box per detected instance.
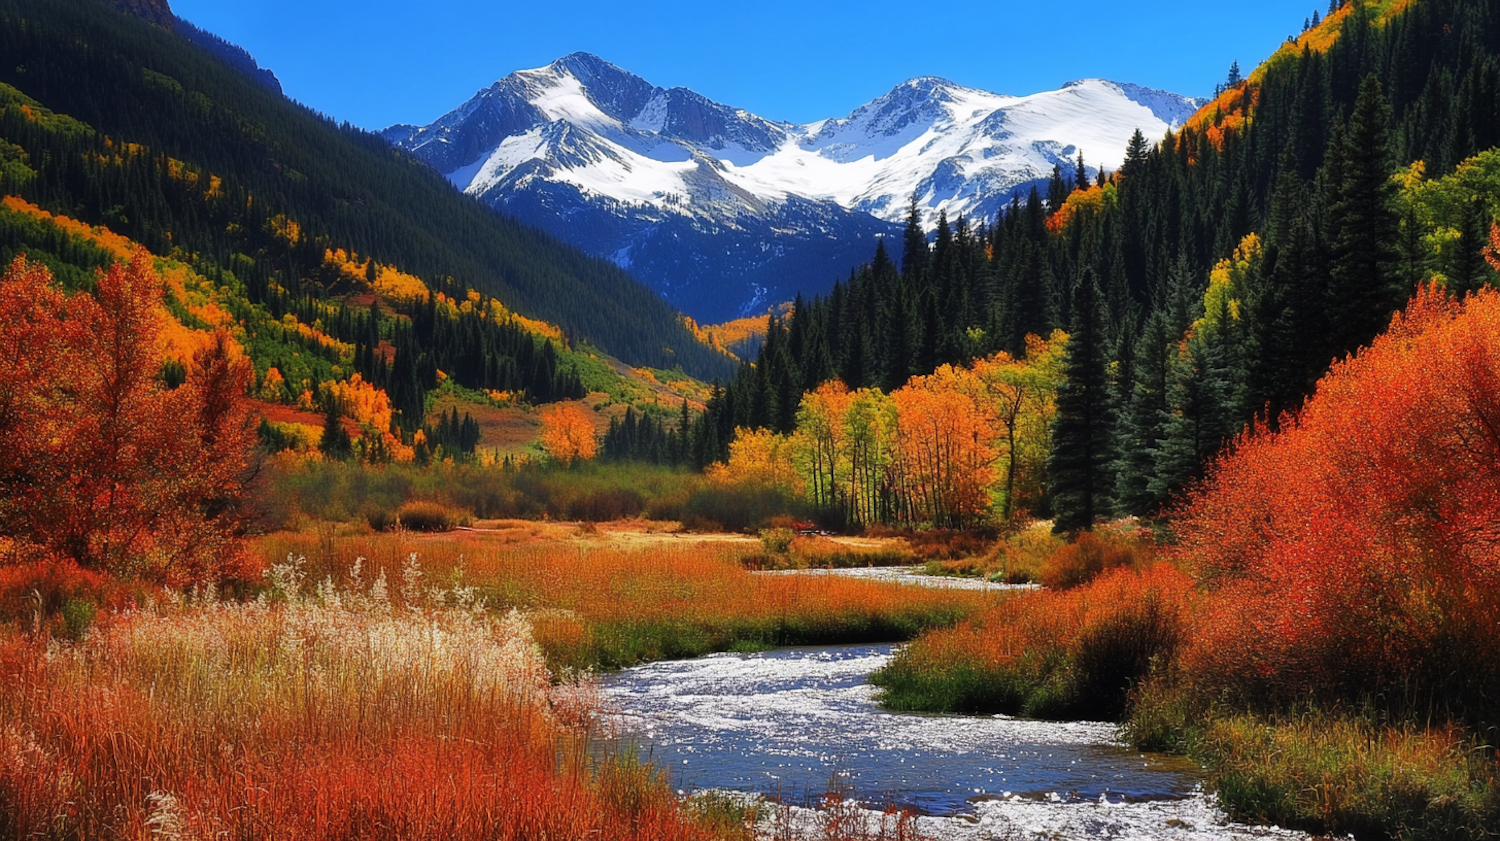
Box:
[0,250,254,580]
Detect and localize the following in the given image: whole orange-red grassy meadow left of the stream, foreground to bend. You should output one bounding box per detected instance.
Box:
[0,522,993,841]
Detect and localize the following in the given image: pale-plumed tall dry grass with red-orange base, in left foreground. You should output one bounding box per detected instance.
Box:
[0,565,710,841]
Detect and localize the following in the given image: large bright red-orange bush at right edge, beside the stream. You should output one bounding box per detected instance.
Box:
[1176,286,1500,703]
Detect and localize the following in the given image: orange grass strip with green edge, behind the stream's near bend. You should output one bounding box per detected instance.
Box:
[258,529,995,670]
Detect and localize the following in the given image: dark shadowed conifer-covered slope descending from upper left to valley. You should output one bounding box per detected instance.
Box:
[0,0,729,378]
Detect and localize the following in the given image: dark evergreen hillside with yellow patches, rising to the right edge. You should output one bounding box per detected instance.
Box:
[695,0,1500,528]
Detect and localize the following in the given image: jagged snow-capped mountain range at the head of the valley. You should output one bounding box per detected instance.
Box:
[386,52,1199,321]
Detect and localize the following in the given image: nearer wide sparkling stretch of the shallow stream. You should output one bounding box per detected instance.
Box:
[605,645,1299,840]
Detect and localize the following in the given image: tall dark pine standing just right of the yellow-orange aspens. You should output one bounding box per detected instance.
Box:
[1047,270,1115,534]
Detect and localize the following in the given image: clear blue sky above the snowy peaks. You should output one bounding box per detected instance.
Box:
[171,0,1328,129]
